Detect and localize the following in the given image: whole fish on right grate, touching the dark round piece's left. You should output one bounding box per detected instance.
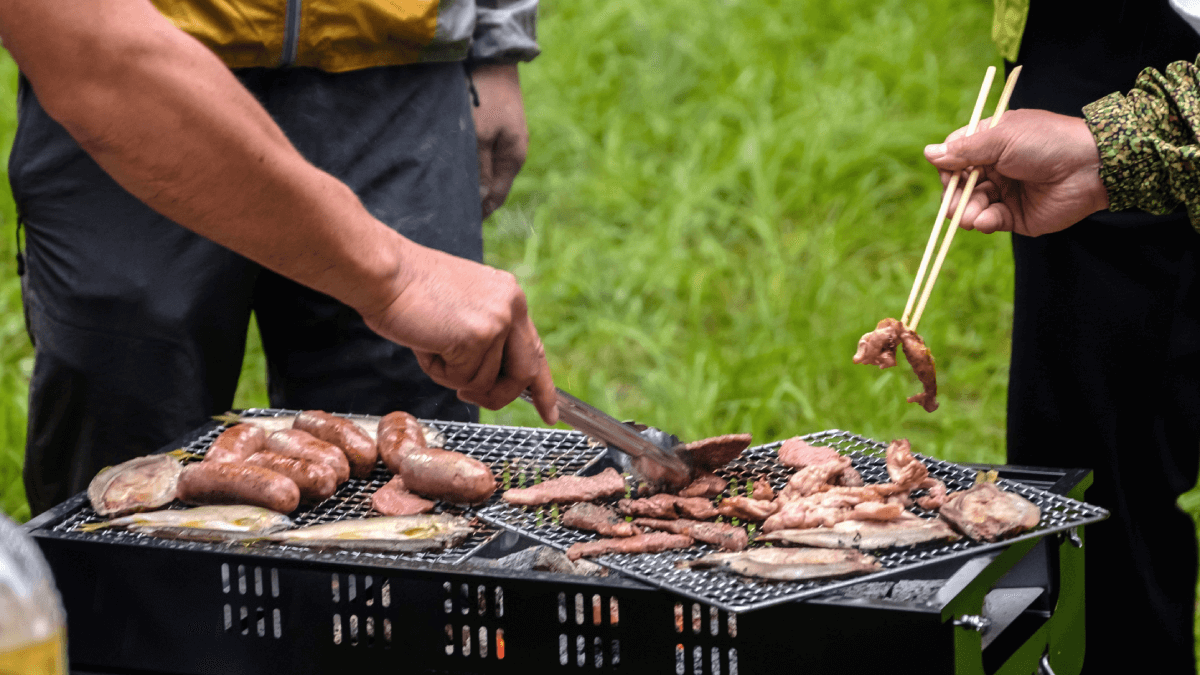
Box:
[757,512,960,550]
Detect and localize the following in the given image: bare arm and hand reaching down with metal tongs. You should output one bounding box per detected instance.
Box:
[0,0,556,422]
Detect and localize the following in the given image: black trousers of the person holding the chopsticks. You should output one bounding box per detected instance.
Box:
[1008,214,1200,674]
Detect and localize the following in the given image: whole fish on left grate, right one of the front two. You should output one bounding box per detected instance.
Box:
[263,514,473,552]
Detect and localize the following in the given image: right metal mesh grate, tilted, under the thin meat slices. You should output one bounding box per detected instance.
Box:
[479,430,1108,613]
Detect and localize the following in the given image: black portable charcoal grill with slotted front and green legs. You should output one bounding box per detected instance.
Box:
[26,411,1104,675]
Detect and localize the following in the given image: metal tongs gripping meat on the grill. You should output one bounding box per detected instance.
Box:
[521,387,692,488]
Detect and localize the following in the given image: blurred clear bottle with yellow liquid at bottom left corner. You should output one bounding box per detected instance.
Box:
[0,514,67,675]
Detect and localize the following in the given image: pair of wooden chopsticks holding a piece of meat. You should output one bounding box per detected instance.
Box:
[900,66,1021,333]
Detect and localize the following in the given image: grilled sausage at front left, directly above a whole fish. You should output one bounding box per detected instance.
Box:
[175,461,300,513]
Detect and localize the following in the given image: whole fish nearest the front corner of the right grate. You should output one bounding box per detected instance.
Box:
[676,548,882,581]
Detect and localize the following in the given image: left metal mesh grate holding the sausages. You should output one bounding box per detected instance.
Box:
[52,408,600,565]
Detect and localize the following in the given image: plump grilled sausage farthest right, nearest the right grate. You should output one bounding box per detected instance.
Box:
[398,448,496,504]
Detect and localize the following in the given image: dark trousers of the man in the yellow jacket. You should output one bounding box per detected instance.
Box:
[10,64,482,514]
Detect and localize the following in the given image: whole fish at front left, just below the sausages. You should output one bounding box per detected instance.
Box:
[82,506,293,542]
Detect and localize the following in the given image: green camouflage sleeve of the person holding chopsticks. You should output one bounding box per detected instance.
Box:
[1084,59,1200,229]
